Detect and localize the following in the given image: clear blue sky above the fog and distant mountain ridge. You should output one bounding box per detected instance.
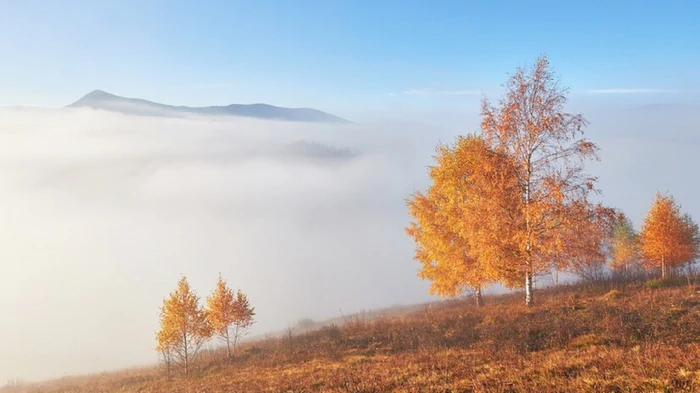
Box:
[0,0,700,115]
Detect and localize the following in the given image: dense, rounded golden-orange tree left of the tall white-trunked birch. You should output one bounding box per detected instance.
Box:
[406,135,520,306]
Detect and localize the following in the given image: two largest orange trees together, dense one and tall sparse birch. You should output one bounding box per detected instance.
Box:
[407,57,606,304]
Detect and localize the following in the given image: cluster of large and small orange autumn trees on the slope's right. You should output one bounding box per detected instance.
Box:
[406,56,700,305]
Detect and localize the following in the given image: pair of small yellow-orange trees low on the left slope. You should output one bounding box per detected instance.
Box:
[156,275,255,375]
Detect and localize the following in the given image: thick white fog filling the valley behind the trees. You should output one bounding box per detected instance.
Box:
[0,103,700,384]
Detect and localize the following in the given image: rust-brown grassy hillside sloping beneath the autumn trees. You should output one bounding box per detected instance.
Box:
[2,282,700,393]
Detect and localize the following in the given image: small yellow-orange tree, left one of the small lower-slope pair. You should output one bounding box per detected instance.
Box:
[156,277,212,374]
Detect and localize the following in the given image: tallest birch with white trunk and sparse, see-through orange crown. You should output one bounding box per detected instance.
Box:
[481,56,602,305]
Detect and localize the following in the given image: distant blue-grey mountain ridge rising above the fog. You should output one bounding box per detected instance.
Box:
[68,90,350,123]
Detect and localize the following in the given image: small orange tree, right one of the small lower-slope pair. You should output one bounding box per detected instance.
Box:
[206,275,255,357]
